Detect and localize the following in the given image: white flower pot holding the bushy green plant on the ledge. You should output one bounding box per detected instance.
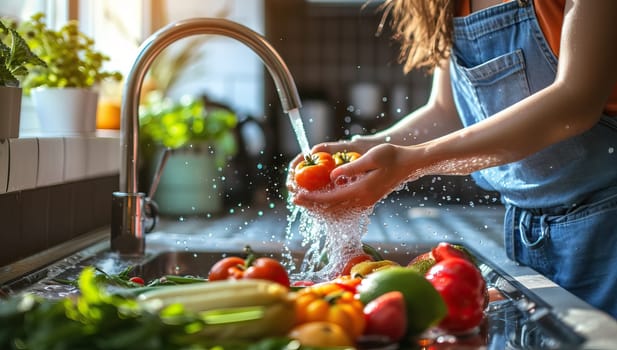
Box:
[31,87,99,134]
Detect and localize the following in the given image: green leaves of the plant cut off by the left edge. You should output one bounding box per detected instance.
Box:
[0,21,46,86]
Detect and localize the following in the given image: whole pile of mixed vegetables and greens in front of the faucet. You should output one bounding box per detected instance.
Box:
[0,243,488,350]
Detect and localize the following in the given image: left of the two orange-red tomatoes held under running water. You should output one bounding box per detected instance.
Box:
[294,152,335,191]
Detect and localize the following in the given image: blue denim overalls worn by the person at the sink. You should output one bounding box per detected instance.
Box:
[450,0,617,318]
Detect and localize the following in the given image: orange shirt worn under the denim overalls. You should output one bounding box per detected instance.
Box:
[456,0,617,116]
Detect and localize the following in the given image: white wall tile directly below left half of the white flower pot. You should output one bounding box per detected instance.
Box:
[36,137,64,187]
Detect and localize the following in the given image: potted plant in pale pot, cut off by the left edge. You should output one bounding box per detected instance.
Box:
[0,20,45,139]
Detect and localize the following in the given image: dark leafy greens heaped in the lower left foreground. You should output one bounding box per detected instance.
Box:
[0,267,312,350]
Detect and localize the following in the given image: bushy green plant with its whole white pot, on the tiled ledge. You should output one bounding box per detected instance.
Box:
[18,13,122,133]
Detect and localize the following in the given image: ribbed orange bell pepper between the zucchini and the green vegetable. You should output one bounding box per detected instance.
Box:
[295,282,366,339]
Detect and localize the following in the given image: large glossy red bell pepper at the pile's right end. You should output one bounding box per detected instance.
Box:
[426,256,487,333]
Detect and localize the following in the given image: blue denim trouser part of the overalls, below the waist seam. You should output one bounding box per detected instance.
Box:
[504,187,617,318]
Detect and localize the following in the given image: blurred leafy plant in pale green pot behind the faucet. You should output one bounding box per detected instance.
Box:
[139,91,238,216]
